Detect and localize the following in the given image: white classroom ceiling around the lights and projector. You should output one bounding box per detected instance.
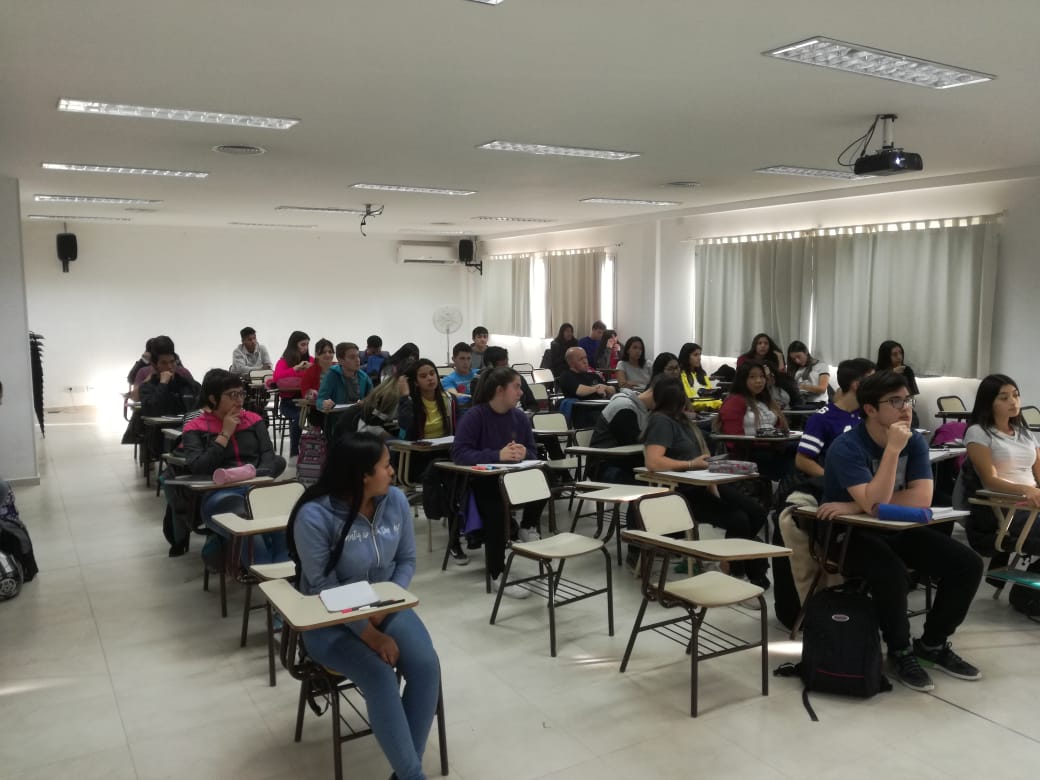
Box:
[0,0,1040,240]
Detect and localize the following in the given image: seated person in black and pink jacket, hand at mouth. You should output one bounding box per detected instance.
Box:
[183,368,288,566]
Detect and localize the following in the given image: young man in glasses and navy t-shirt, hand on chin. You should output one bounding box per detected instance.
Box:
[816,371,982,691]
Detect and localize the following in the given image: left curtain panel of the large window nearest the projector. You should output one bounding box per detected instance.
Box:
[694,235,813,355]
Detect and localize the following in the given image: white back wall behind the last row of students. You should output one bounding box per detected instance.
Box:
[21,223,479,408]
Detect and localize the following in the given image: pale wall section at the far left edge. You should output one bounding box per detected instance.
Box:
[0,177,38,482]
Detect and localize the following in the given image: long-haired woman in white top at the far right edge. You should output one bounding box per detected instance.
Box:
[964,373,1040,567]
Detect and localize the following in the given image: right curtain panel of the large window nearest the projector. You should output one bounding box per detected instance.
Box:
[814,217,998,376]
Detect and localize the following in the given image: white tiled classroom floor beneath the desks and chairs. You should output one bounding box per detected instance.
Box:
[0,414,1040,780]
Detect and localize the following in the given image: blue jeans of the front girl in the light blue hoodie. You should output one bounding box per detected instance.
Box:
[304,609,441,780]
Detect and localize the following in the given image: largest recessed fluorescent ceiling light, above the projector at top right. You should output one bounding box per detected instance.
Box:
[762,36,996,89]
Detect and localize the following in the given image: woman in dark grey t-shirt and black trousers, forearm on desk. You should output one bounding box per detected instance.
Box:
[644,379,770,590]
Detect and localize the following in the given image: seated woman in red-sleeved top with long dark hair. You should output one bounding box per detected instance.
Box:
[716,360,795,482]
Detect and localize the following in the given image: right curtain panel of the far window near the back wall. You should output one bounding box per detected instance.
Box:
[546,249,606,337]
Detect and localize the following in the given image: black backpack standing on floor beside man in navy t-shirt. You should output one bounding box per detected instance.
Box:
[776,586,892,721]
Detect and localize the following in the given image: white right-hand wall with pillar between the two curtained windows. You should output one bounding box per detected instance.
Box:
[486,178,1040,404]
